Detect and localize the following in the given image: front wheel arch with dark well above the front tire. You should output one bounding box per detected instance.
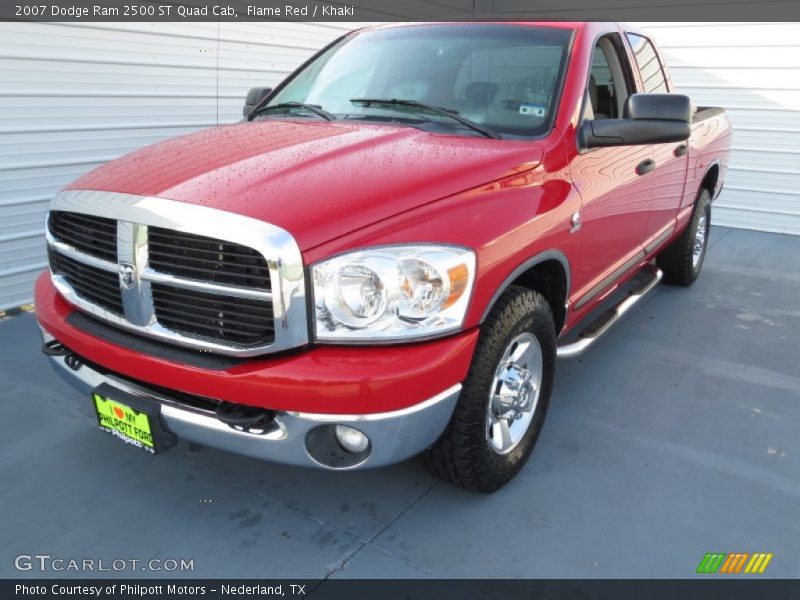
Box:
[480,250,572,333]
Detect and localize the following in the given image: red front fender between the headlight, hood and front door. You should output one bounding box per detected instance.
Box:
[305,168,581,329]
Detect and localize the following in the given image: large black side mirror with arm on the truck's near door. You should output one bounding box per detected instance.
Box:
[578,94,694,149]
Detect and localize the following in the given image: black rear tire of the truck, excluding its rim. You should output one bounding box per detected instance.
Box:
[656,189,711,286]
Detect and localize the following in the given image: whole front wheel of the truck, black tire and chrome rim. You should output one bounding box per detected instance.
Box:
[424,286,556,493]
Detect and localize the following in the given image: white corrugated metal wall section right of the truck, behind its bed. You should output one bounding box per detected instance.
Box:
[642,23,800,235]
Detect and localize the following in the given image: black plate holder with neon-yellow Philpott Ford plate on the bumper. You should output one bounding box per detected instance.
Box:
[92,383,177,454]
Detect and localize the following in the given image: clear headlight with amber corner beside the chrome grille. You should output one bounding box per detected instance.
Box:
[311,245,475,342]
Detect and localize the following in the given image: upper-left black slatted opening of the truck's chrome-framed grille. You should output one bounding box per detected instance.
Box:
[49,210,117,262]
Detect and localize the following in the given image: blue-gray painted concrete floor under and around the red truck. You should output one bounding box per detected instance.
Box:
[0,228,800,578]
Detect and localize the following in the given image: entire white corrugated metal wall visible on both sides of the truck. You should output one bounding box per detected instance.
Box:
[0,23,800,310]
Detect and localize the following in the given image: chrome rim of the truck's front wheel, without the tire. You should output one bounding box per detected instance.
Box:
[486,332,544,454]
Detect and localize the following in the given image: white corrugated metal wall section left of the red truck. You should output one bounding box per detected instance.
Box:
[0,22,358,310]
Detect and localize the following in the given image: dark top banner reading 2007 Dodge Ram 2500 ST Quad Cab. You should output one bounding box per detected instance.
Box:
[0,0,800,22]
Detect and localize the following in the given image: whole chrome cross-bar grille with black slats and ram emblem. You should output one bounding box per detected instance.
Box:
[46,191,308,356]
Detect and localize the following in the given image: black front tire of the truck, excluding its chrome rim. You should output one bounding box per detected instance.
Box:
[423,286,556,493]
